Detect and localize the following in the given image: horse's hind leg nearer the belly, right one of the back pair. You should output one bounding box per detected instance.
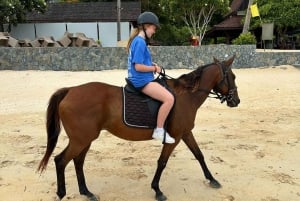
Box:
[73,144,97,201]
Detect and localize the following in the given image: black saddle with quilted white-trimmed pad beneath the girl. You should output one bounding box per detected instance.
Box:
[123,78,170,129]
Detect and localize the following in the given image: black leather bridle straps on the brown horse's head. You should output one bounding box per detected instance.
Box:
[208,63,237,103]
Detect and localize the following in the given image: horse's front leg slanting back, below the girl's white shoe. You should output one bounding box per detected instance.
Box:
[151,142,177,201]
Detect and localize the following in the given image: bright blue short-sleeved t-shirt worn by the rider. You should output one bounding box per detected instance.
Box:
[128,36,154,87]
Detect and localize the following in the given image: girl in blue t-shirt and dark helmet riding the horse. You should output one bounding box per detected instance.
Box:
[127,12,175,143]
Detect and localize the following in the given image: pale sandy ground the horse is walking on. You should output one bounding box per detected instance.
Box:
[0,66,300,201]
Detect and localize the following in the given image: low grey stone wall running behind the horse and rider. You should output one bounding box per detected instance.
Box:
[0,45,300,71]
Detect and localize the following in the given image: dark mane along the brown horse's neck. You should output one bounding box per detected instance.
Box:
[173,63,213,93]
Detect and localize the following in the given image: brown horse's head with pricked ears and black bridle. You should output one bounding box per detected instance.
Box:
[213,55,240,107]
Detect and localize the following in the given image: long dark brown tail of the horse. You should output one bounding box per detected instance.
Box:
[38,88,69,172]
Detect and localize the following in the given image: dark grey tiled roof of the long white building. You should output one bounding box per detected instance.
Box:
[26,1,141,22]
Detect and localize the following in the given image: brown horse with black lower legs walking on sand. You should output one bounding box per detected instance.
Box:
[38,57,240,201]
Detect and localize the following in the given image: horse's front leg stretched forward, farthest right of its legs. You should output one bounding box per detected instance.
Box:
[182,132,221,188]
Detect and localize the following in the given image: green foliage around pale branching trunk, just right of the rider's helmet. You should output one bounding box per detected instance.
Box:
[155,0,229,45]
